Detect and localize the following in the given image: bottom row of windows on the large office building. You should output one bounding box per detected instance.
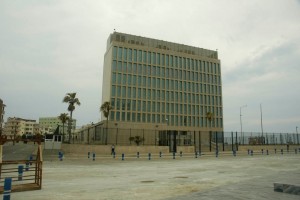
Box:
[110,111,223,128]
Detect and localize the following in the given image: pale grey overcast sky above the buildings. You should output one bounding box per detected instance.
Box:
[0,0,300,133]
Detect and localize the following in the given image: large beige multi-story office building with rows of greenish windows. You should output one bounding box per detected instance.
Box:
[102,32,223,150]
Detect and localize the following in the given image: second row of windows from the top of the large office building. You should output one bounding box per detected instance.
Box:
[113,63,221,85]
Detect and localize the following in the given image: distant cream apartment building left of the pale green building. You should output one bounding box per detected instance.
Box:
[3,117,36,136]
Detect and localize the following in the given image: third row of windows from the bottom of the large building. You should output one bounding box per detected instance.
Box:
[111,85,222,106]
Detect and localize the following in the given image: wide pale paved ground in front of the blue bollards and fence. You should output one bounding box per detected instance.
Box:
[4,145,300,200]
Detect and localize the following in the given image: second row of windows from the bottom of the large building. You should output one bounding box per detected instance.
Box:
[111,98,223,117]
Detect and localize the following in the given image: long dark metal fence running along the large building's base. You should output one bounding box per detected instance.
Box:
[73,126,300,151]
